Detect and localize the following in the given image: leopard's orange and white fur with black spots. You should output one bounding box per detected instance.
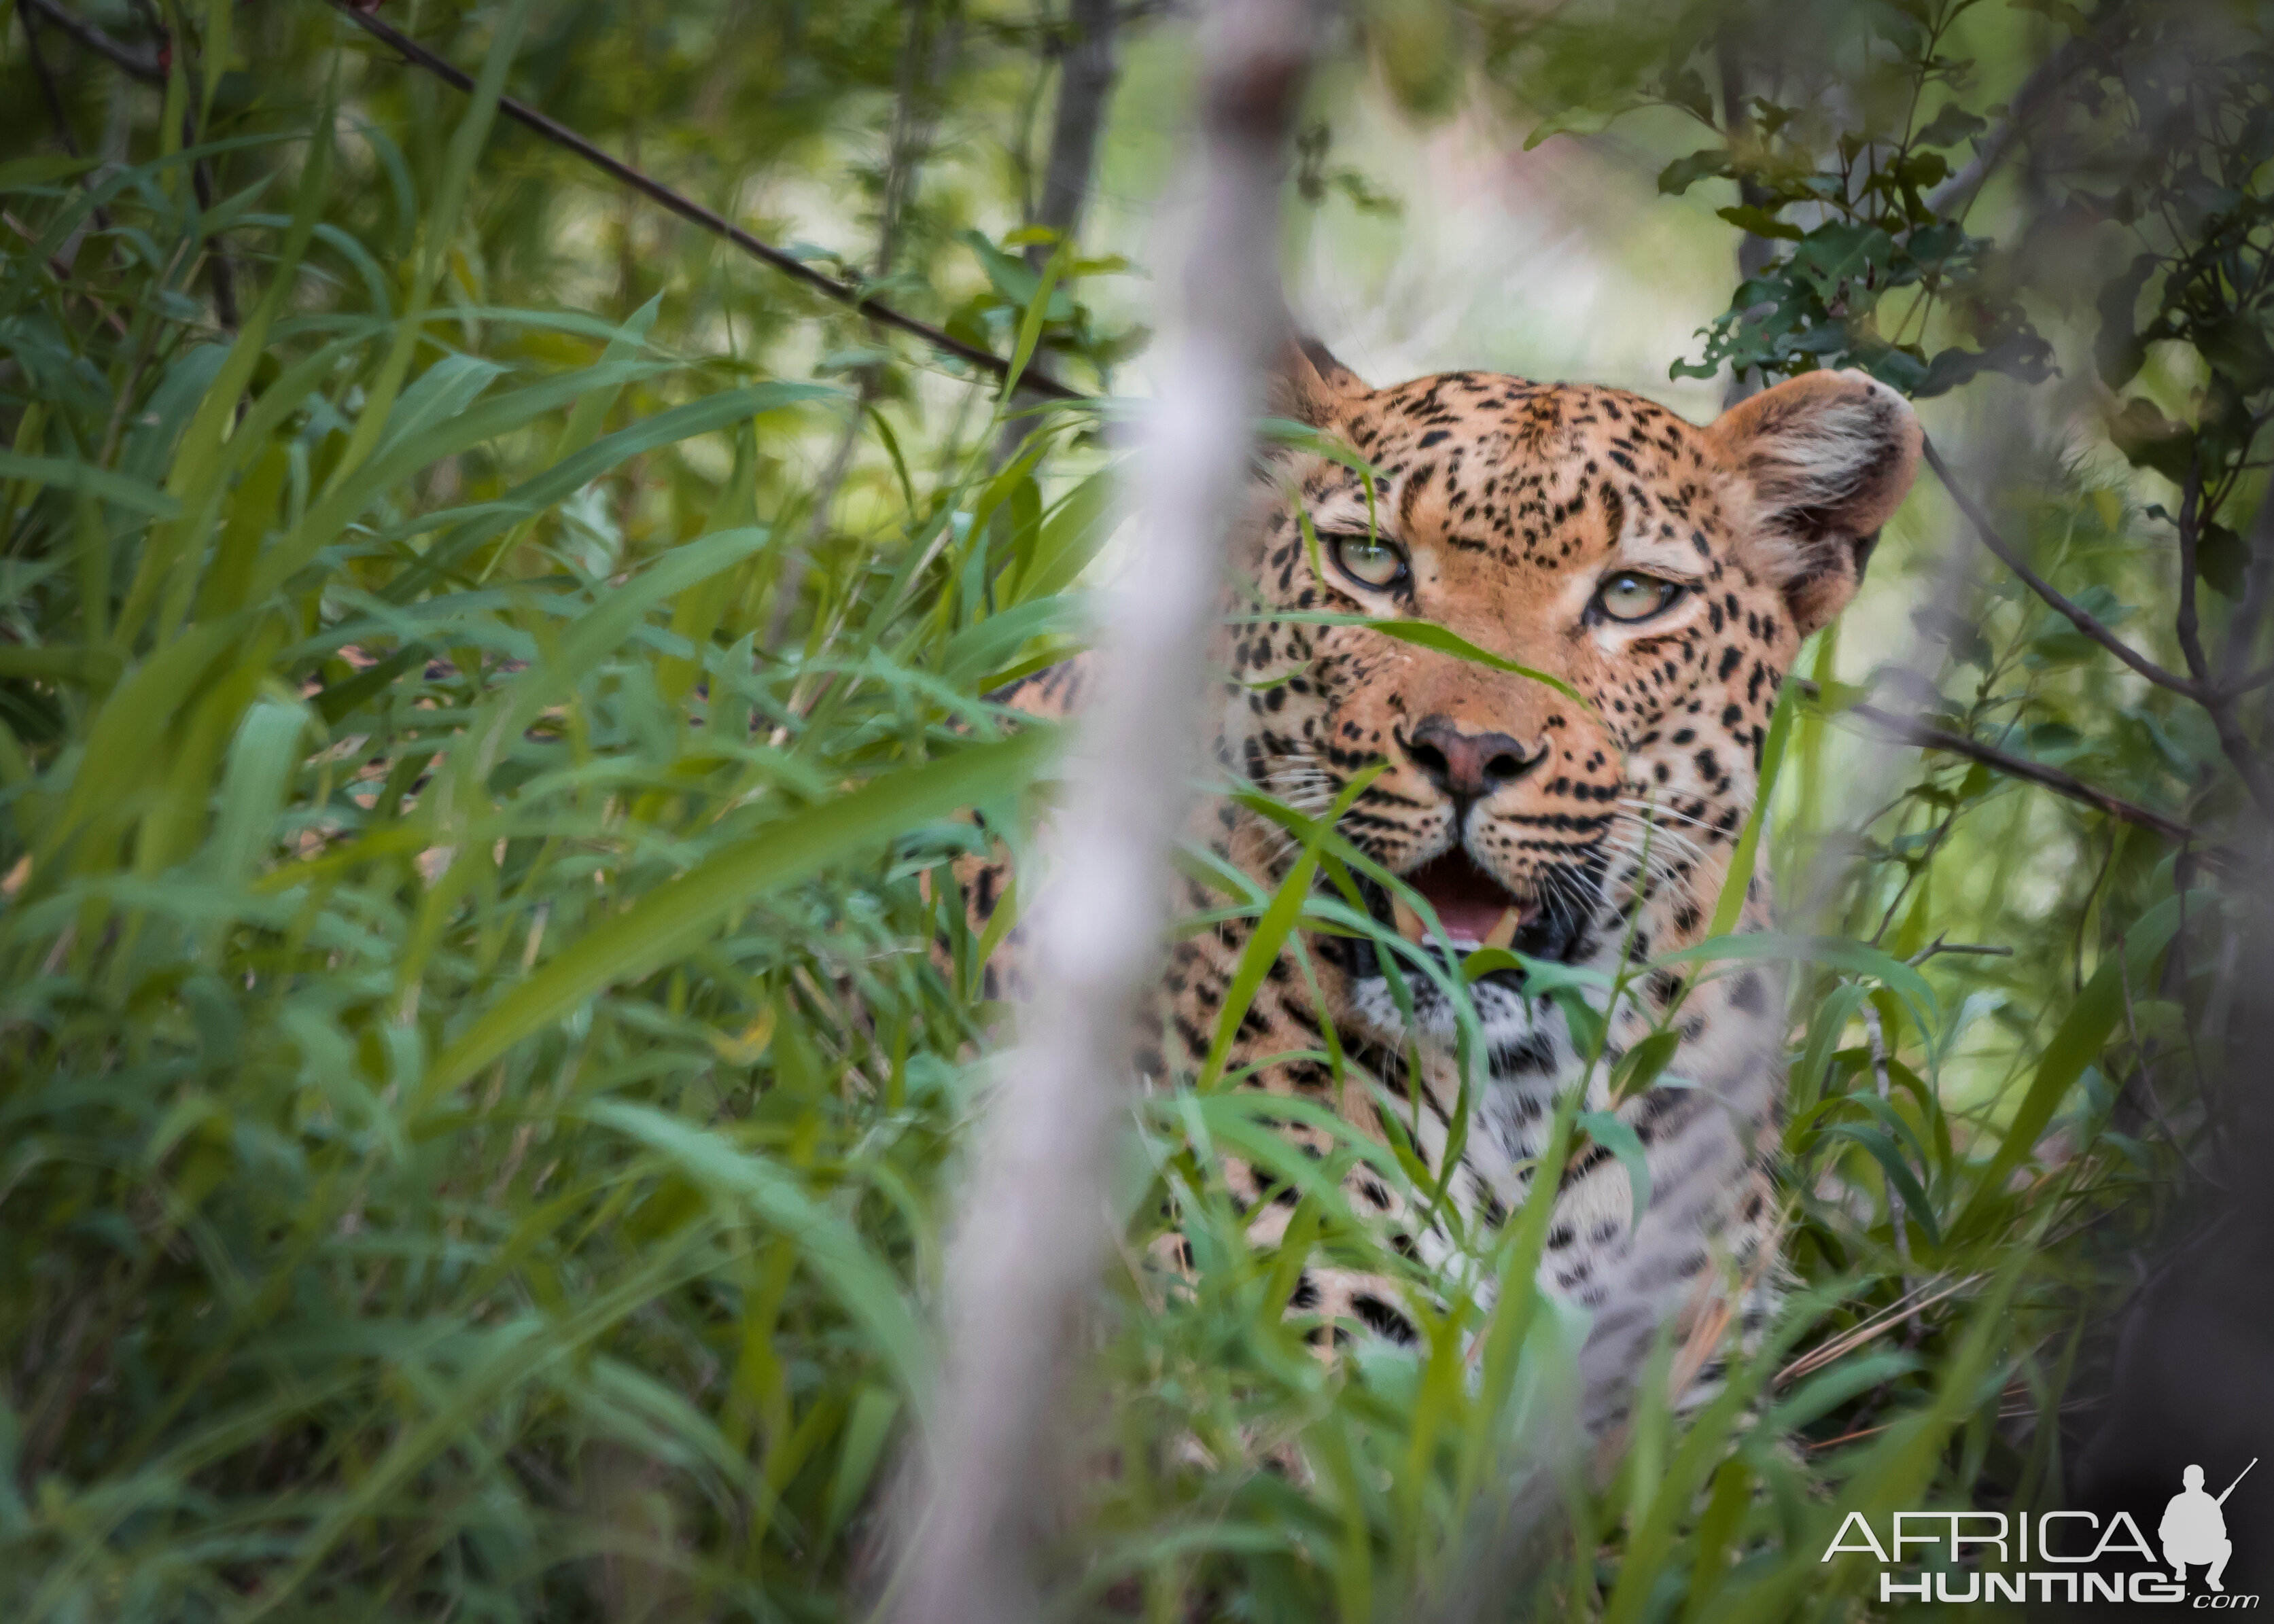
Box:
[966,343,1919,1417]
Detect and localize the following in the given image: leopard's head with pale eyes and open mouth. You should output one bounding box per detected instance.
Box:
[1223,341,1919,1037]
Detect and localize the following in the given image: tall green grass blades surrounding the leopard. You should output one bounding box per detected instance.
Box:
[0,9,2213,1624]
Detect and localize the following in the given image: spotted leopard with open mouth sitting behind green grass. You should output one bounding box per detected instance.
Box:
[960,336,1921,1428]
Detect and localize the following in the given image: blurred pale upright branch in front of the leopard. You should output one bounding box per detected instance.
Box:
[889,0,1323,1624]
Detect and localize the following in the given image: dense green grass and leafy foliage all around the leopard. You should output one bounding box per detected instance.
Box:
[0,0,2274,1624]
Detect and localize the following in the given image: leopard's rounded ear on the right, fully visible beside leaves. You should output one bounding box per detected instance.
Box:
[1706,371,1921,637]
